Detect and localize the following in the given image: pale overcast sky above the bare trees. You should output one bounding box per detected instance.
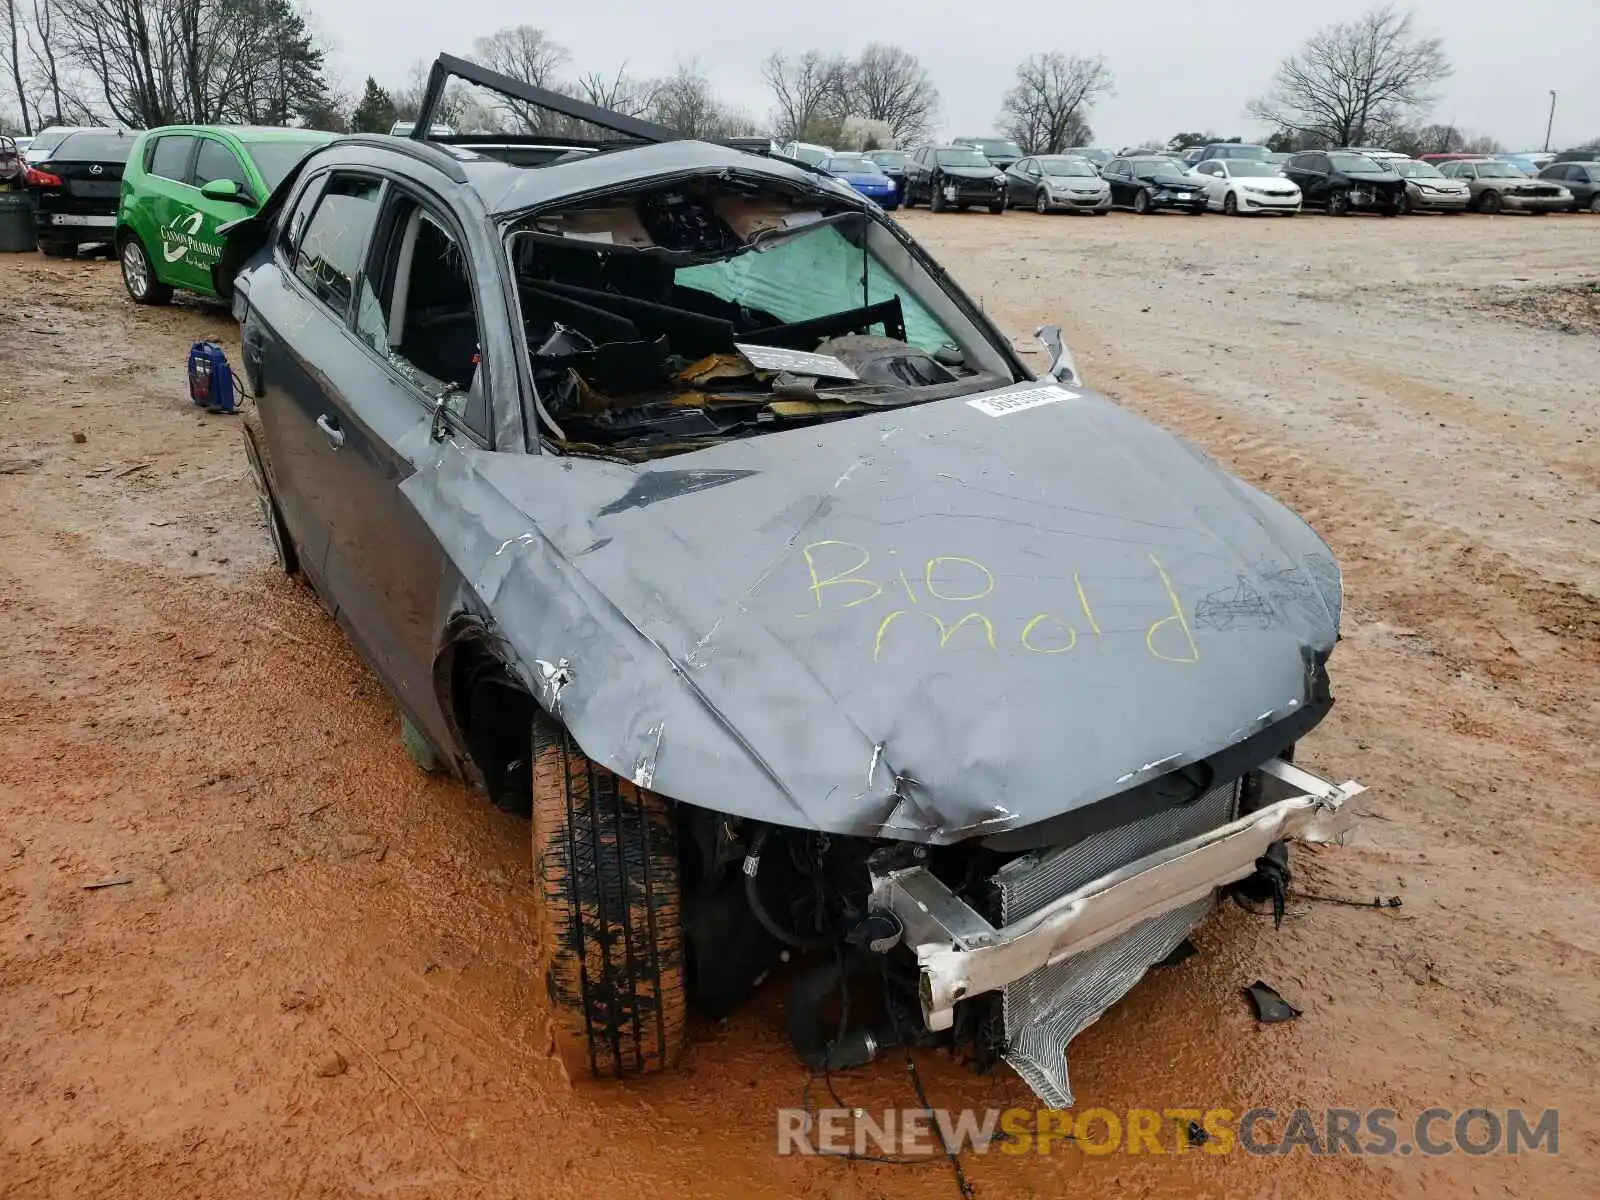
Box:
[310,0,1600,150]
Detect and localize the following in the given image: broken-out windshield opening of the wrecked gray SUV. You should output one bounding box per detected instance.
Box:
[509,178,1014,461]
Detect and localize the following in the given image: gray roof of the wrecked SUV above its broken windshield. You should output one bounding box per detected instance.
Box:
[306,133,856,216]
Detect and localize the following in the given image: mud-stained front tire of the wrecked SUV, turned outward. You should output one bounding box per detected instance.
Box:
[533,731,688,1077]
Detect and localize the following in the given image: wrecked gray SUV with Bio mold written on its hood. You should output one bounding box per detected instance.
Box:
[218,58,1360,1106]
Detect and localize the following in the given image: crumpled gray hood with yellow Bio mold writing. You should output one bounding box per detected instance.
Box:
[402,382,1339,842]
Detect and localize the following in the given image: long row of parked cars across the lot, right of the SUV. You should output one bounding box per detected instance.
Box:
[778,138,1600,216]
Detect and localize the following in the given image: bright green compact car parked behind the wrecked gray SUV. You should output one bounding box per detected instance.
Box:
[117,125,338,304]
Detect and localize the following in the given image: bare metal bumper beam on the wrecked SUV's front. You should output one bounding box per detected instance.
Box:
[872,758,1366,1029]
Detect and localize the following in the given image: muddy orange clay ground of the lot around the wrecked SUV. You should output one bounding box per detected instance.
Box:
[0,213,1600,1200]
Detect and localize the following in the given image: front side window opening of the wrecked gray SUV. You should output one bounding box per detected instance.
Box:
[355,192,488,437]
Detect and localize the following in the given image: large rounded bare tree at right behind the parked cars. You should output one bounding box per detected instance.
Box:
[1250,5,1450,146]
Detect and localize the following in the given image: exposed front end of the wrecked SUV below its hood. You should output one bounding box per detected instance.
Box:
[685,757,1363,1107]
